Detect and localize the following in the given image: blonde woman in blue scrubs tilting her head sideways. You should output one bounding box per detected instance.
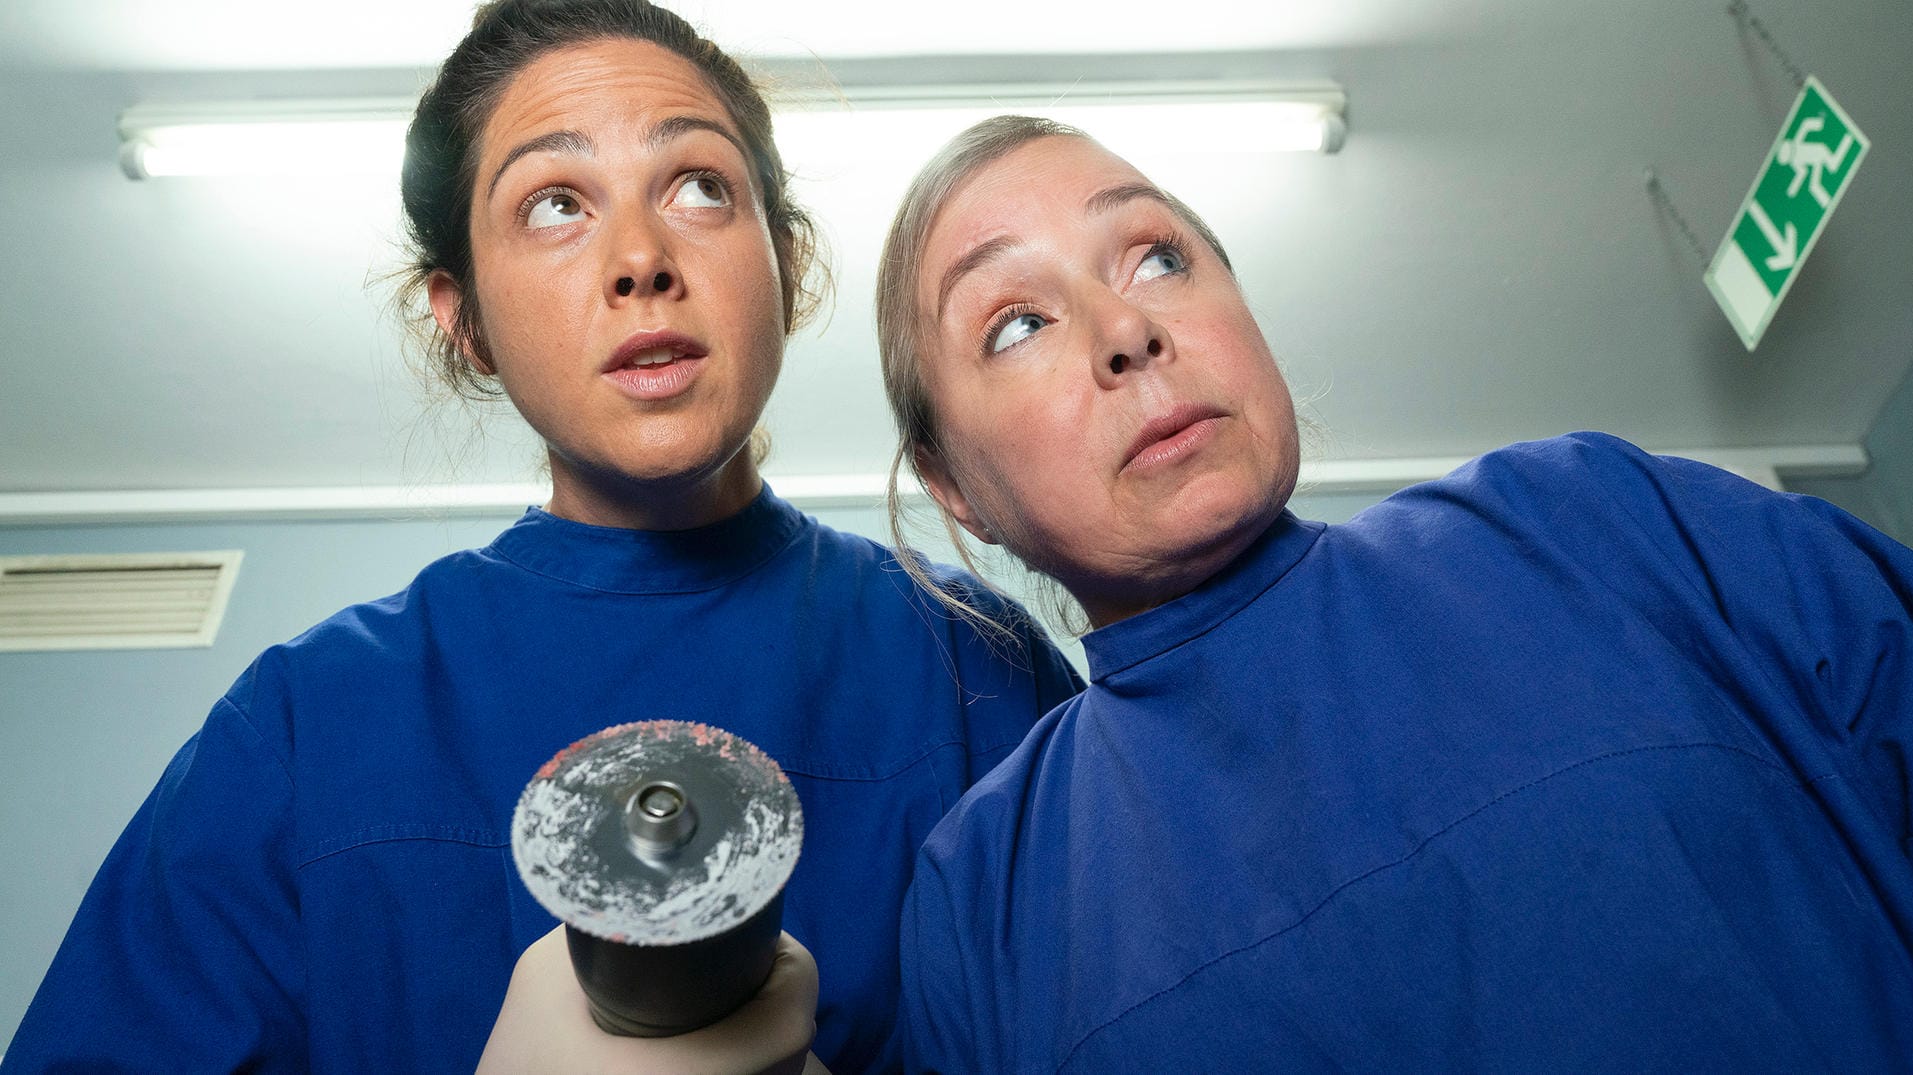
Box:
[878,117,1913,1071]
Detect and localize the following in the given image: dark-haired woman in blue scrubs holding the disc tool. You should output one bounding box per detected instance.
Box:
[6,10,1075,1075]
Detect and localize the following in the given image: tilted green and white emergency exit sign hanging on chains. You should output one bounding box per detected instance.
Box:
[1703,77,1867,350]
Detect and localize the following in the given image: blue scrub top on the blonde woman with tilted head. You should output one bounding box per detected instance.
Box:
[903,434,1913,1073]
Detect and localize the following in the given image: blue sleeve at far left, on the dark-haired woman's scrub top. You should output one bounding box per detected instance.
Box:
[6,688,304,1071]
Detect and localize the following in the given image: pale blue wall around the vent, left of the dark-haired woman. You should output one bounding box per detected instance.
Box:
[0,516,524,1041]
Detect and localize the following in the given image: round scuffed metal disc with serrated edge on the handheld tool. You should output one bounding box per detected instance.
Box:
[511,721,803,945]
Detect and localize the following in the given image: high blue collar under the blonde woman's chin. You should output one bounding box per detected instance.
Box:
[1083,511,1328,683]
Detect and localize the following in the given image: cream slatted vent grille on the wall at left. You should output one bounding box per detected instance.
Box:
[0,549,243,650]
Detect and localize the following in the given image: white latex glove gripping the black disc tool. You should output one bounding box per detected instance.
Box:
[478,926,823,1075]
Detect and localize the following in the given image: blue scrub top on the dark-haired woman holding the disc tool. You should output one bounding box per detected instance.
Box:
[6,490,1077,1075]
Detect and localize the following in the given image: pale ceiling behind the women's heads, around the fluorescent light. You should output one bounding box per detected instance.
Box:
[0,0,1913,494]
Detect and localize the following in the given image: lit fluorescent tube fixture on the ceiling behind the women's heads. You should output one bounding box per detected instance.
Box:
[119,80,1347,180]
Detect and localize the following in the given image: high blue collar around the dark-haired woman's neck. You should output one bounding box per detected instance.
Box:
[490,484,803,593]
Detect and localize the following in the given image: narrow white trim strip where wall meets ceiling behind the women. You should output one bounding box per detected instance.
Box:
[0,444,1867,526]
